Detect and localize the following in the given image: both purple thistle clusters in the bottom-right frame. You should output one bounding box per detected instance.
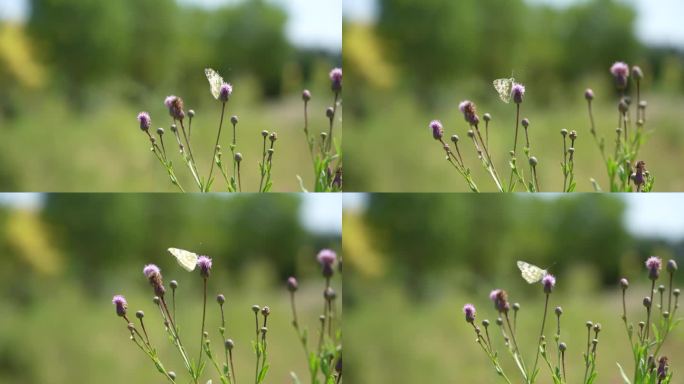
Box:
[463,257,680,384]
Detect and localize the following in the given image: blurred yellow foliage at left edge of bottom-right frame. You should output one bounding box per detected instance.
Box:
[342,212,385,277]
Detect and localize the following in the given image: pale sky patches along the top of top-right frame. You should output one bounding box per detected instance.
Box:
[344,0,684,48]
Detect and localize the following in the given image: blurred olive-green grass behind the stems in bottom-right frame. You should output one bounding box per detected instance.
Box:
[345,273,684,384]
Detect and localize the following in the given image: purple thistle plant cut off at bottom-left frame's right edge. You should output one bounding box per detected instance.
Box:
[287,249,342,384]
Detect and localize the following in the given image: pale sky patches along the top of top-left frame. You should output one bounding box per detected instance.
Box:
[0,0,343,51]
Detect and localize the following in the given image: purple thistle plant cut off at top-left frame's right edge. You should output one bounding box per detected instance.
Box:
[297,68,342,192]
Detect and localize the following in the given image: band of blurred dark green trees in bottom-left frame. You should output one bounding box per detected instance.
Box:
[43,194,309,289]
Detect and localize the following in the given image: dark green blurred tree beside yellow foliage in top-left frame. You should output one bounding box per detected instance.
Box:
[28,0,133,98]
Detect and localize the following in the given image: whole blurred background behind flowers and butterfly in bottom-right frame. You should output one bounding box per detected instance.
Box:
[343,194,684,384]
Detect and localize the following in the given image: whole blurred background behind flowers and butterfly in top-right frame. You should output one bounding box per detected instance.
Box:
[343,0,684,192]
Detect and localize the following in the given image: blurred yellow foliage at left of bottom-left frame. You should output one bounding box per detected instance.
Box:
[6,209,63,276]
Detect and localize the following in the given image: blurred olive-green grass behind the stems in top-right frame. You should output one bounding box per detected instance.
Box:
[345,87,684,192]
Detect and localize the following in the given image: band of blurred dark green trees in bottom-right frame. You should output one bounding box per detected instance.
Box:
[366,194,629,295]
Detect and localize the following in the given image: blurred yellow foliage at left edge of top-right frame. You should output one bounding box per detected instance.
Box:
[343,24,397,88]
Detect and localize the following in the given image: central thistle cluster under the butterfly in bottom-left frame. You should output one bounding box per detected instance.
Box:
[112,256,271,384]
